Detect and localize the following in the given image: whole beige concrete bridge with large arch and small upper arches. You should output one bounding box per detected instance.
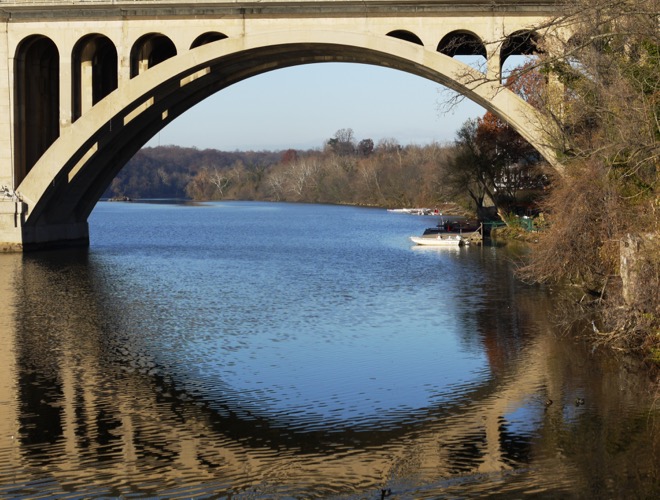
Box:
[0,0,556,251]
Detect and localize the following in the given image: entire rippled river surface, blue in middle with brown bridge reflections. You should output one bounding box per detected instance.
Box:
[0,202,660,499]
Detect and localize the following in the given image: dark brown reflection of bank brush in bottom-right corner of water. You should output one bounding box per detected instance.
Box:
[539,335,660,498]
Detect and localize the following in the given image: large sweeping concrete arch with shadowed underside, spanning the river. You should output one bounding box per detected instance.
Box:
[18,32,552,249]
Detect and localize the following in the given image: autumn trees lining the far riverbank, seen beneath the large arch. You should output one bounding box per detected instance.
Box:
[105,113,546,214]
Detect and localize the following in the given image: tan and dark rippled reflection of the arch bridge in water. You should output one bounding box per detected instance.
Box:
[0,256,576,495]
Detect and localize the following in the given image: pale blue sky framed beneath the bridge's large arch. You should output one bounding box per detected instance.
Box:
[147,63,485,151]
